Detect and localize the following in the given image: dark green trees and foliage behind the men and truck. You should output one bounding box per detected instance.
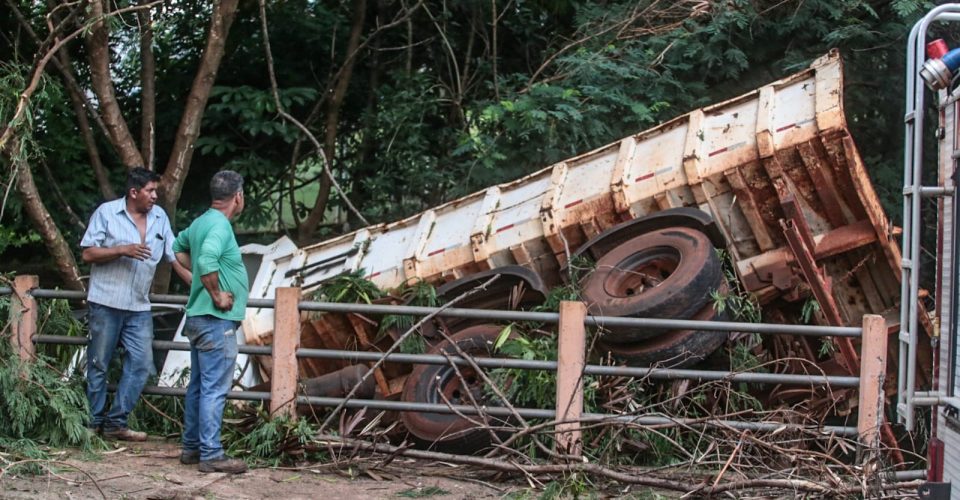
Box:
[0,0,956,288]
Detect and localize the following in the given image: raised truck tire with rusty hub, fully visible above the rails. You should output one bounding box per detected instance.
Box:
[582,227,723,343]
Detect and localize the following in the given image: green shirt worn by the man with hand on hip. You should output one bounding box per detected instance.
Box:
[173,208,250,321]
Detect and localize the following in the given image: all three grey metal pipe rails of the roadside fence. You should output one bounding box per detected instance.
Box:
[0,287,876,446]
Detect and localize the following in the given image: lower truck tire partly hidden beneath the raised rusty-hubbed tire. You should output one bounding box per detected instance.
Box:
[594,286,727,368]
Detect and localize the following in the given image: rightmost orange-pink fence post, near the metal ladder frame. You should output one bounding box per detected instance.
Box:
[857,314,887,449]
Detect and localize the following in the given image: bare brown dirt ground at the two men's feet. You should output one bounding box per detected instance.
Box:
[0,440,516,500]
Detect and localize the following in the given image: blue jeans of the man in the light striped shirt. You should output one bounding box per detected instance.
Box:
[87,302,156,430]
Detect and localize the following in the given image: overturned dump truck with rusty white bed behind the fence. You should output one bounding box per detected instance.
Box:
[171,52,928,452]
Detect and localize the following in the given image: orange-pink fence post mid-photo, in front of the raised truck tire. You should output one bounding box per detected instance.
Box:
[556,301,587,457]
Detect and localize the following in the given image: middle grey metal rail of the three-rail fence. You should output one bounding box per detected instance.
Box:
[34,335,860,388]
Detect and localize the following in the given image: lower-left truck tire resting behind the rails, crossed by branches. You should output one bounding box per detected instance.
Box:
[401,324,506,454]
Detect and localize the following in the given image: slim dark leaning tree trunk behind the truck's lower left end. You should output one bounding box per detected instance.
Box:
[297,0,367,242]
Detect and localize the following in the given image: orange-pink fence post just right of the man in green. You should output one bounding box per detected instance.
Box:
[270,287,300,418]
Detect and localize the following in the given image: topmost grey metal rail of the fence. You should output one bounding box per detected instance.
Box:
[16,288,863,337]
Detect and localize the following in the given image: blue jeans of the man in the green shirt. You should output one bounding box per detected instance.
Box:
[183,315,238,461]
